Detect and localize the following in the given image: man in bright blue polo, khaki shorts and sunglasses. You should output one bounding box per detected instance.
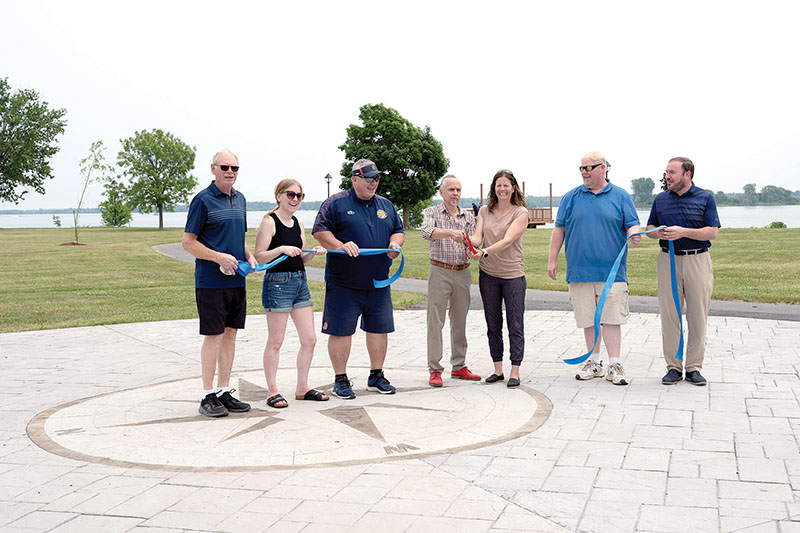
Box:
[547,152,641,385]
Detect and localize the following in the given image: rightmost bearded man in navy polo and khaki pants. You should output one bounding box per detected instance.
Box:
[647,157,720,385]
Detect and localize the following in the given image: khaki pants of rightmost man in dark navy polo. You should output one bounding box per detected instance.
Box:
[658,252,714,372]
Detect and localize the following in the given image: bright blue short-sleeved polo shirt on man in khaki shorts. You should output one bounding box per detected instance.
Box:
[555,182,639,283]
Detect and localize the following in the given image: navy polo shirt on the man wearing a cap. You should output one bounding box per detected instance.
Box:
[312,188,404,290]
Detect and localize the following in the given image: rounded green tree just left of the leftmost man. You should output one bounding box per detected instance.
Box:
[117,129,197,229]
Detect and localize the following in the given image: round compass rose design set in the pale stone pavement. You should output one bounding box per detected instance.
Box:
[28,368,552,471]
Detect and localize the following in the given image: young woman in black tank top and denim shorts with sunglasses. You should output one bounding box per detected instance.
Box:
[254,179,328,409]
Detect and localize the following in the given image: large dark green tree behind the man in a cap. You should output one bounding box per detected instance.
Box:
[339,104,450,227]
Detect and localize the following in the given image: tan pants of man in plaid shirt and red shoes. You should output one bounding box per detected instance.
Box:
[428,265,470,372]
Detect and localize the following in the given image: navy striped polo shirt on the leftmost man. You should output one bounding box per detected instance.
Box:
[184,182,247,289]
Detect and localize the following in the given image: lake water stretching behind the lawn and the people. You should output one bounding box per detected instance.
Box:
[0,205,800,229]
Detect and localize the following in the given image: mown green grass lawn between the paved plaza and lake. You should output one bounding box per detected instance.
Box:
[0,228,800,332]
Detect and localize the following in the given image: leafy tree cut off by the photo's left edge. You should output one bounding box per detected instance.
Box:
[0,78,67,204]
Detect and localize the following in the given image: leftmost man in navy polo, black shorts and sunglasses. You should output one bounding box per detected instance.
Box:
[182,150,256,417]
